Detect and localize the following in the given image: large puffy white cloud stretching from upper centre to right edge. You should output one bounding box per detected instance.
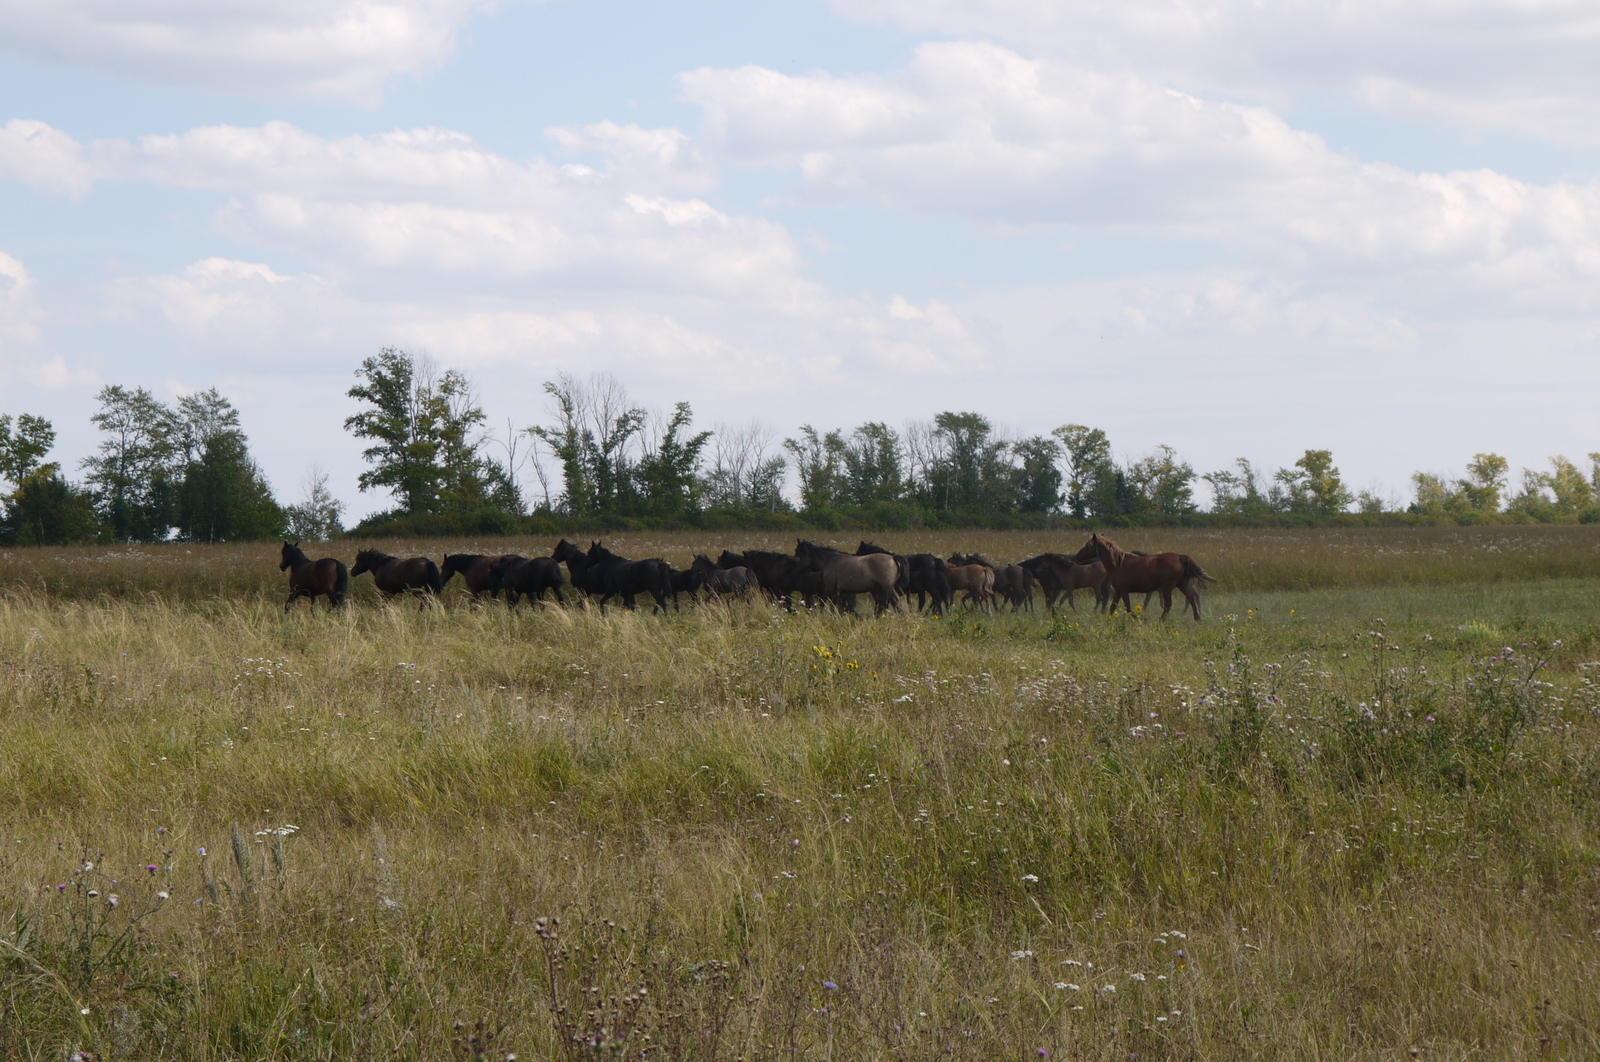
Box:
[683,42,1600,305]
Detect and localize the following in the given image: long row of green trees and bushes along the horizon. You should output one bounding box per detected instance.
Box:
[0,347,1600,544]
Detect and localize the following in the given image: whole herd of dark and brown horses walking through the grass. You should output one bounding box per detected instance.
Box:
[278,534,1216,621]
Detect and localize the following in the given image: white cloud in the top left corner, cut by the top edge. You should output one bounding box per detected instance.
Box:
[0,0,496,104]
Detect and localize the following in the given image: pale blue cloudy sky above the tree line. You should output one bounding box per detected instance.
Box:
[0,0,1600,515]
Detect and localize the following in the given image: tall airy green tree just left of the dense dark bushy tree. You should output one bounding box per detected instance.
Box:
[83,385,179,541]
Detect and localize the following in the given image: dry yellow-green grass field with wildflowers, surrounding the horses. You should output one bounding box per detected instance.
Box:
[0,528,1600,1060]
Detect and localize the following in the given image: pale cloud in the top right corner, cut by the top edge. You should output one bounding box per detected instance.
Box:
[832,0,1600,144]
